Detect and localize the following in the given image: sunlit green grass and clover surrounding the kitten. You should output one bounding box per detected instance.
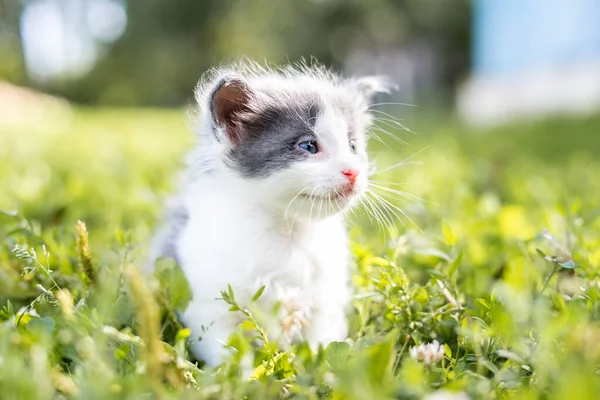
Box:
[0,109,600,400]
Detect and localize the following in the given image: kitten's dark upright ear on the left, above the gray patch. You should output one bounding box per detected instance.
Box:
[210,75,254,144]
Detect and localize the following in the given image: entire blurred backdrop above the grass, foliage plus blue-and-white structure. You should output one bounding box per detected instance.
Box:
[0,0,600,119]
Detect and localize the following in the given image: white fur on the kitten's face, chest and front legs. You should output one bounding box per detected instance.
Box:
[150,63,384,366]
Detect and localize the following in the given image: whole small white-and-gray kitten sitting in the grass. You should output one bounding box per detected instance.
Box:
[151,61,387,366]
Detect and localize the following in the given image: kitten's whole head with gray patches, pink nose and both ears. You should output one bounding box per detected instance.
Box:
[199,61,394,218]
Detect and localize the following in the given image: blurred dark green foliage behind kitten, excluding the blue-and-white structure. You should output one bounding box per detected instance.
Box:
[0,0,471,106]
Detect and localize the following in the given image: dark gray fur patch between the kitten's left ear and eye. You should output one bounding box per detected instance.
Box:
[228,93,322,178]
